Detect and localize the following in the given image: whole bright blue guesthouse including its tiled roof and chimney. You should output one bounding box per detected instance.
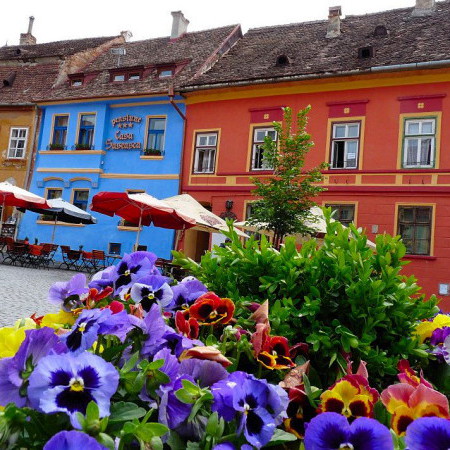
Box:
[19,12,242,258]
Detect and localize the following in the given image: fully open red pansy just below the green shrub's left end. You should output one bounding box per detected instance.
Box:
[189,292,234,325]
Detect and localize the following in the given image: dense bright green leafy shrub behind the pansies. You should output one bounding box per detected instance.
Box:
[175,210,438,386]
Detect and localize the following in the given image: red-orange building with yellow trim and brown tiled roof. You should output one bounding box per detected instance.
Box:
[182,0,450,310]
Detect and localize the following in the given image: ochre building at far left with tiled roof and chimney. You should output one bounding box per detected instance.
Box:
[0,17,125,235]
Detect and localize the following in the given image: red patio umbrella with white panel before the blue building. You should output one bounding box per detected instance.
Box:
[91,192,196,248]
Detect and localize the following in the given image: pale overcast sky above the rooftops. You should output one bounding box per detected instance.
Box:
[0,0,415,46]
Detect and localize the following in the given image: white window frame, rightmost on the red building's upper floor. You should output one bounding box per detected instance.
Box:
[403,117,436,169]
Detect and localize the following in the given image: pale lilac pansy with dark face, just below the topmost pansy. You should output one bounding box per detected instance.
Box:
[130,275,173,312]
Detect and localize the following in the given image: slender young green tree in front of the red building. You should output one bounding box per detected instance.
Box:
[248,106,327,248]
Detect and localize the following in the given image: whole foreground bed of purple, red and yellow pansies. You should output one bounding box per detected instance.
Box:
[0,233,450,450]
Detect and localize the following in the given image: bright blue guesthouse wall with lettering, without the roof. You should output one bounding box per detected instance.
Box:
[20,96,185,258]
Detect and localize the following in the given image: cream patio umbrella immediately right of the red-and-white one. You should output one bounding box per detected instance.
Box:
[163,194,248,237]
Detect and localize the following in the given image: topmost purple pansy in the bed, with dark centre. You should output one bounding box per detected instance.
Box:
[114,252,159,294]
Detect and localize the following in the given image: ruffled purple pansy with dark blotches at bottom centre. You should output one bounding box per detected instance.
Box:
[211,372,288,448]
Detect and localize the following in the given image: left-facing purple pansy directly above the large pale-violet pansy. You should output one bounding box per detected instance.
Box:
[61,309,132,354]
